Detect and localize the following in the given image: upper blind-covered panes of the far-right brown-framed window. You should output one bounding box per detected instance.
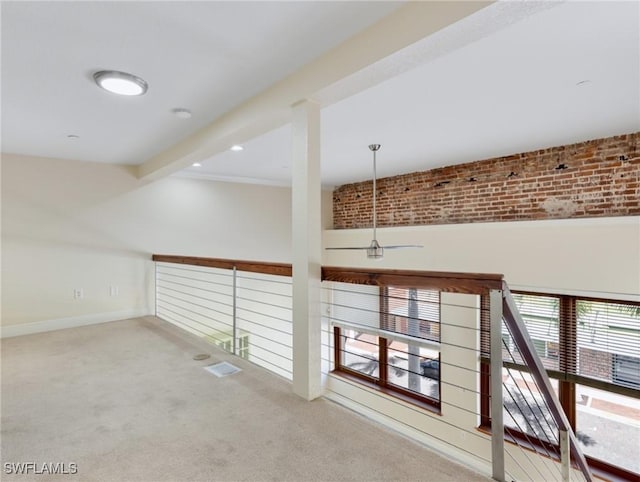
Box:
[480,293,640,393]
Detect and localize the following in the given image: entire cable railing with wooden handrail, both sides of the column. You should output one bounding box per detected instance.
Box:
[153,255,591,480]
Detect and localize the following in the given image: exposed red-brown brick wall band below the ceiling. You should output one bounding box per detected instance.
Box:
[333,132,640,229]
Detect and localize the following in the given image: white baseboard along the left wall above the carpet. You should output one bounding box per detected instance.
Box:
[0,309,152,338]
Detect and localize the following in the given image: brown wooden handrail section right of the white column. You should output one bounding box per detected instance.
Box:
[322,266,504,294]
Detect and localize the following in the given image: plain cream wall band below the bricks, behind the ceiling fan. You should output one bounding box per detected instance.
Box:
[323,216,640,301]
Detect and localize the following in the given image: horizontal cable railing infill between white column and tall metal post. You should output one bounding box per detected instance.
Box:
[322,282,491,476]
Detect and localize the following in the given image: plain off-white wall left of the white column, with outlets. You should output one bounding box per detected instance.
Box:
[1,154,291,336]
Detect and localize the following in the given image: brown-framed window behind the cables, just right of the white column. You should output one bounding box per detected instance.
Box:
[333,285,440,409]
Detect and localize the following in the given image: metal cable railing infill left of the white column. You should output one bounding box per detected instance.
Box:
[156,262,293,380]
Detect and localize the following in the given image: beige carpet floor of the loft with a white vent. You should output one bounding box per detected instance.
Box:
[0,317,490,482]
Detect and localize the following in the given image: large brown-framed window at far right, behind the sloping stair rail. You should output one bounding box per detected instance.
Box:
[481,293,640,479]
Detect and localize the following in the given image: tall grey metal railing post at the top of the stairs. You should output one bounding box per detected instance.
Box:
[489,290,505,482]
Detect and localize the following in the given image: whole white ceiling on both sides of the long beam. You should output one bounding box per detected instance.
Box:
[2,1,640,186]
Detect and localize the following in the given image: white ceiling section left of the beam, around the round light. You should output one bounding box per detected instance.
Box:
[1,1,400,164]
